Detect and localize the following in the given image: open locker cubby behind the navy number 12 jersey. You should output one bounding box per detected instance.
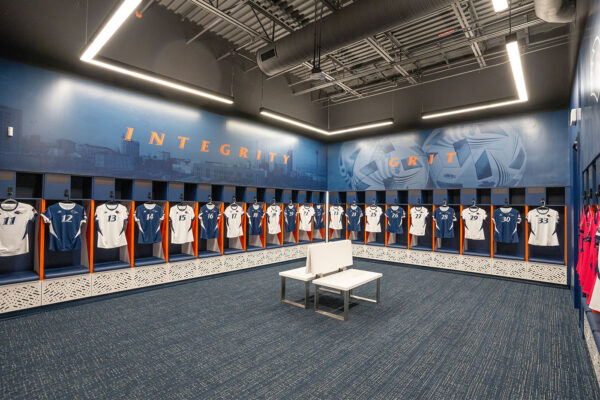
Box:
[41,200,90,279]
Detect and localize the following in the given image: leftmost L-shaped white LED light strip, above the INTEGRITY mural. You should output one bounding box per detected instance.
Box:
[80,0,233,104]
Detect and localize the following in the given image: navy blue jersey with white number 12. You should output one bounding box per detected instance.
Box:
[42,203,87,251]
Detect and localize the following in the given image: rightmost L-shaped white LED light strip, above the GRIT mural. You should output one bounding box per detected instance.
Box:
[421,35,529,119]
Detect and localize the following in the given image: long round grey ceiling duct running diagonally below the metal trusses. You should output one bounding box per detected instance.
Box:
[256,0,454,76]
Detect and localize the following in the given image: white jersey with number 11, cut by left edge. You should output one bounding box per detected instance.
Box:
[0,203,37,257]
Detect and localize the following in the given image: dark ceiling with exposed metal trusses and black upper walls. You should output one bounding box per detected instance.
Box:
[0,0,570,141]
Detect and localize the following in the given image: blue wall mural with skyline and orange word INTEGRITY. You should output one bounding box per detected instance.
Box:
[0,59,327,190]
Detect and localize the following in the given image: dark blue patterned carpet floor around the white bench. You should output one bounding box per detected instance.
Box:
[0,261,600,399]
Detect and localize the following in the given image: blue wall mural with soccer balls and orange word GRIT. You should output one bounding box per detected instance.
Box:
[328,111,569,191]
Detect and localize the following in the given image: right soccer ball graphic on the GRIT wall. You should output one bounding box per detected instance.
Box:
[423,124,527,188]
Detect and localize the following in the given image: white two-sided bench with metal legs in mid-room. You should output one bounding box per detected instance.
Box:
[279,240,383,321]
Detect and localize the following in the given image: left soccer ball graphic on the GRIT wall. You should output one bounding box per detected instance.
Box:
[339,138,429,190]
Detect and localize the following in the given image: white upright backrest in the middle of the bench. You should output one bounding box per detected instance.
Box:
[306,240,352,275]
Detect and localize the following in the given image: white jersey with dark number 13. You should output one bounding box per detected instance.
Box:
[94,203,129,249]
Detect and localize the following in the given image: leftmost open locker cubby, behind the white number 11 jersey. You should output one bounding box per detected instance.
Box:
[0,200,41,285]
